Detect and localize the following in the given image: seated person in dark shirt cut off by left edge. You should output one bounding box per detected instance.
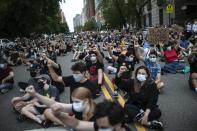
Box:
[0,56,14,93]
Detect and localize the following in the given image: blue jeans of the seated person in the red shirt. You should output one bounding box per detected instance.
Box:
[164,61,185,74]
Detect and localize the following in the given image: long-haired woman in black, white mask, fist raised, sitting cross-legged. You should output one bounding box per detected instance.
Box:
[115,66,163,129]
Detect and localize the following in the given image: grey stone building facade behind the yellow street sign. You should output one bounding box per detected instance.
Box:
[142,0,197,27]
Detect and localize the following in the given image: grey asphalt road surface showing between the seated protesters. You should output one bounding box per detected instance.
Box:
[0,49,197,131]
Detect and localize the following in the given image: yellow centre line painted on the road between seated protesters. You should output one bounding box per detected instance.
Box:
[104,73,147,131]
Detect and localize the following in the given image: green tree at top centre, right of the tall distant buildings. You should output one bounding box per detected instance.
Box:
[99,0,150,29]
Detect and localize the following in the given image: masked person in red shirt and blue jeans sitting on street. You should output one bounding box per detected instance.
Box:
[160,42,185,74]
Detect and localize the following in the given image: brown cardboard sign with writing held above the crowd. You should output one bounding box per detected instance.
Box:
[148,28,169,45]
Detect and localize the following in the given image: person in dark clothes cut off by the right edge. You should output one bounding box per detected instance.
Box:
[188,47,197,93]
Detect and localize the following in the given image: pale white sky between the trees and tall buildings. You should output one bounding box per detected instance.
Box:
[61,0,83,32]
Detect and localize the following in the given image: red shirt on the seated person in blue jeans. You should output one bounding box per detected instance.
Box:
[164,49,178,63]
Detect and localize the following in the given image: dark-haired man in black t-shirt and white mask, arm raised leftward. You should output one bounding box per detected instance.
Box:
[48,61,96,98]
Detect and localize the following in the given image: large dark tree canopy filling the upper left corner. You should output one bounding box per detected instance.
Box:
[0,0,69,37]
